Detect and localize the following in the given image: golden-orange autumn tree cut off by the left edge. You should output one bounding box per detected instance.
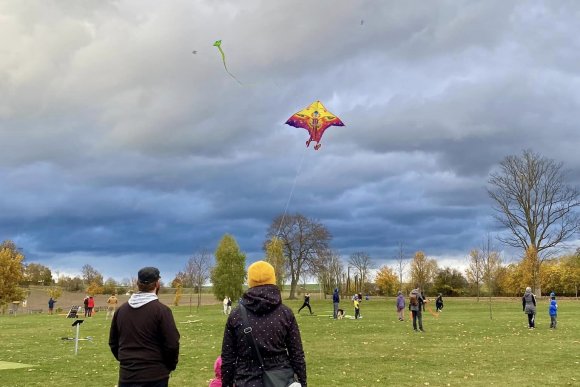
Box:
[0,241,24,310]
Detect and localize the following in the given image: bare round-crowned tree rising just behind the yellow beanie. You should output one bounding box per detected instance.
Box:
[266,214,331,299]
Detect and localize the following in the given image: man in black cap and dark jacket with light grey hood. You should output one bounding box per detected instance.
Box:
[109,267,179,387]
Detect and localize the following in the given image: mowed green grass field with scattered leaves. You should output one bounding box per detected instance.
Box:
[0,298,580,387]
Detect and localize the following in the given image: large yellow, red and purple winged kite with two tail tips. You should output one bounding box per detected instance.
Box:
[286,101,344,150]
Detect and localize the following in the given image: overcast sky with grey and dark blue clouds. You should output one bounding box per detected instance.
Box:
[0,0,580,281]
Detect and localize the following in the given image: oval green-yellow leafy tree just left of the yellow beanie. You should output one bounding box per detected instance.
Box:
[210,234,246,300]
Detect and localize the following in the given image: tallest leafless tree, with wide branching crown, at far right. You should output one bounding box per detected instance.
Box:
[487,150,580,294]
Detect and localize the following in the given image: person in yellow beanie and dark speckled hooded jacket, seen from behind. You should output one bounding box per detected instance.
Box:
[221,261,306,387]
